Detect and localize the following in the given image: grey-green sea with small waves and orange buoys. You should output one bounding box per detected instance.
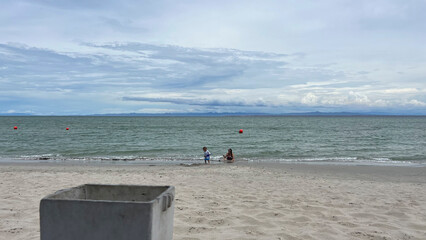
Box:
[0,116,426,166]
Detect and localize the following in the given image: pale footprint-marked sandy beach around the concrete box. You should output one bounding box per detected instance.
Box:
[0,163,426,240]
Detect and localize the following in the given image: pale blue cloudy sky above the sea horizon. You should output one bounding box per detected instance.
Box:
[0,0,426,115]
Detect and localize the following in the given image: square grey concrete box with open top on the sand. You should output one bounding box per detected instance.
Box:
[40,184,175,240]
